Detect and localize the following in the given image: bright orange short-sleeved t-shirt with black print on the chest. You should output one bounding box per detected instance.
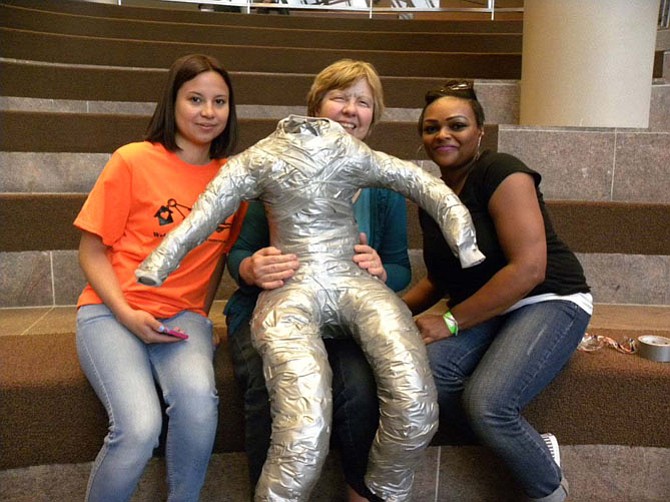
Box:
[74,141,246,318]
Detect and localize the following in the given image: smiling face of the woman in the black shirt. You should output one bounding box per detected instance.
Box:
[421,96,484,173]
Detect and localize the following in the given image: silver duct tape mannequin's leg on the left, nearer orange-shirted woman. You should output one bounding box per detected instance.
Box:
[251,288,332,501]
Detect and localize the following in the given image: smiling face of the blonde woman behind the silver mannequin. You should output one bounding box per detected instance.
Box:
[317,78,374,140]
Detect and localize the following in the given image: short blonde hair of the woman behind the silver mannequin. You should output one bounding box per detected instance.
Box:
[307,59,384,128]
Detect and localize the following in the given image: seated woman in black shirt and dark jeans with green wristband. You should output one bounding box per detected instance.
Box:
[404,81,592,501]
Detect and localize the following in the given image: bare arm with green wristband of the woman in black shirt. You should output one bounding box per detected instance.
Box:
[417,173,547,343]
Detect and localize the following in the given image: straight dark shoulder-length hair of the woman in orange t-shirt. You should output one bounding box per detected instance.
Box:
[144,54,238,159]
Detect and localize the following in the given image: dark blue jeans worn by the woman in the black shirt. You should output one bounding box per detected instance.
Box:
[428,301,590,502]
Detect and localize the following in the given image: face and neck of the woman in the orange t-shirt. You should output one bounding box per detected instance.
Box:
[175,71,230,164]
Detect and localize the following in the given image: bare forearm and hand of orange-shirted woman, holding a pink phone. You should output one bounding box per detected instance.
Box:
[79,231,179,343]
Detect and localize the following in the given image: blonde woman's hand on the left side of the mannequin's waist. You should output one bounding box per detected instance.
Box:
[240,246,299,289]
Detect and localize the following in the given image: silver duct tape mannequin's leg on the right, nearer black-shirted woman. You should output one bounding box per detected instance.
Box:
[342,281,438,501]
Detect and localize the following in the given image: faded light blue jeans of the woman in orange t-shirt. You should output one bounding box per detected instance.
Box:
[77,305,218,502]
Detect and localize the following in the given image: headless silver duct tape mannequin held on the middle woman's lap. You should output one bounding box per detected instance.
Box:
[135,115,484,501]
